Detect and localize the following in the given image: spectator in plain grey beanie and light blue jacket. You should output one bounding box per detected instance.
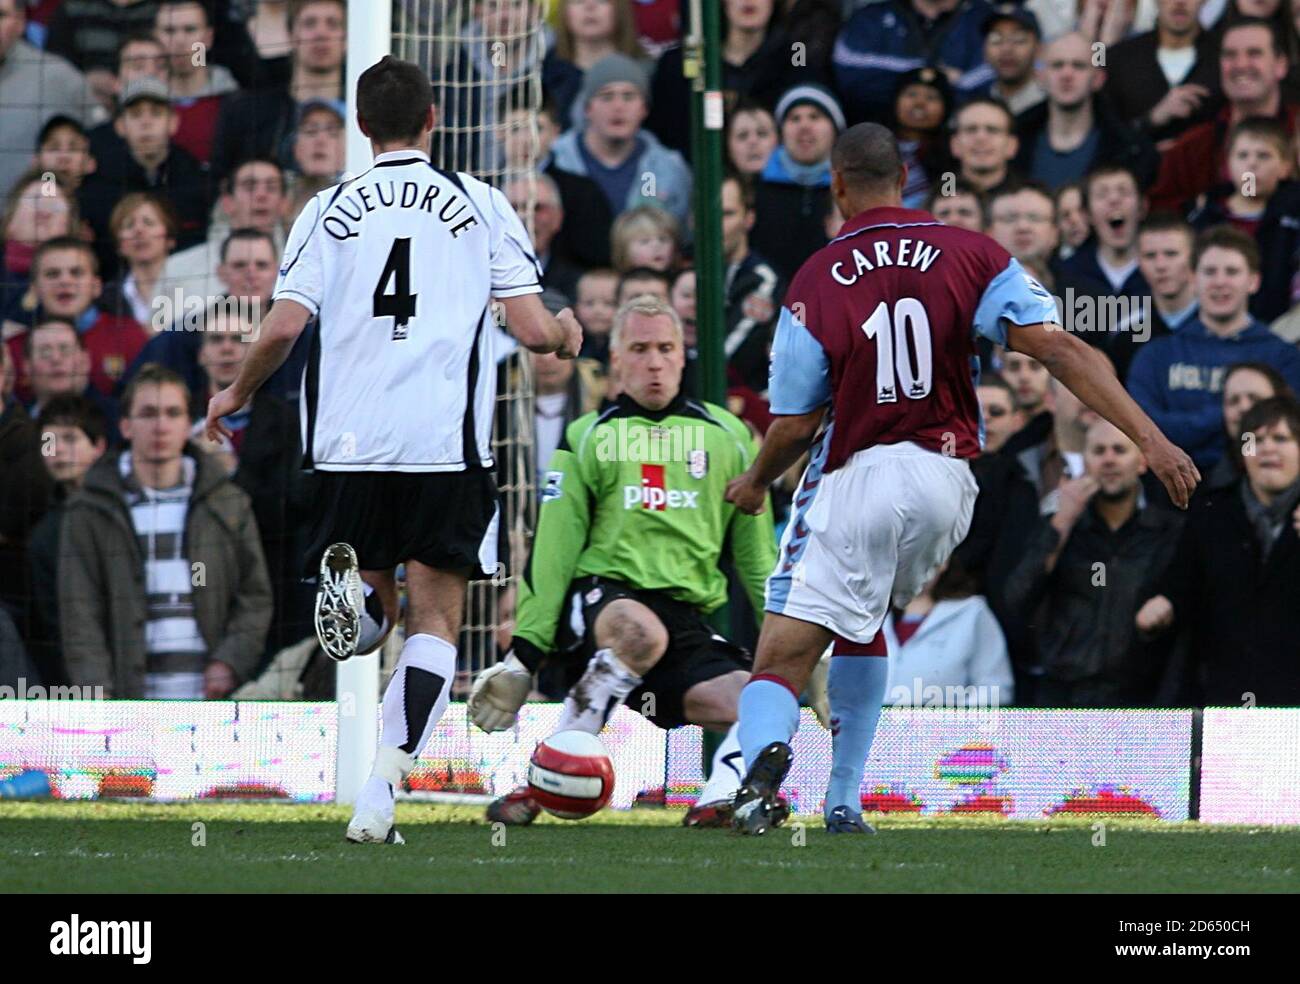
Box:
[551,55,692,234]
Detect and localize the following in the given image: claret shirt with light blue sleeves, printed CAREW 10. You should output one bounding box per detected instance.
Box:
[768,208,1061,471]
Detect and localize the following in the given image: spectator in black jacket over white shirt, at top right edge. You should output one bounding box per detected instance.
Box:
[1102,0,1219,143]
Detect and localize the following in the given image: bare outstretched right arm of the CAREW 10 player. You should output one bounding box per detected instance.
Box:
[1006,324,1201,510]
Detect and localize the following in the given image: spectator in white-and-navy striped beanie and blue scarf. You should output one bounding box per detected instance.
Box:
[749,84,845,283]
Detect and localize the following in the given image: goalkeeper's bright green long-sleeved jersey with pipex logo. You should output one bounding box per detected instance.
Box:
[515,395,776,653]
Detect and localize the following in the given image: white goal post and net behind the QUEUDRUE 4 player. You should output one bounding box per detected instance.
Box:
[335,0,549,803]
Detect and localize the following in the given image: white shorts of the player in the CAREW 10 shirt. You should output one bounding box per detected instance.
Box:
[764,438,979,643]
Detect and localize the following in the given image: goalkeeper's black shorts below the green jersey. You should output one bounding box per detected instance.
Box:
[558,577,754,729]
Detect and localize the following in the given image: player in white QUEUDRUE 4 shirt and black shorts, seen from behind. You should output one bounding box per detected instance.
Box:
[205,56,582,844]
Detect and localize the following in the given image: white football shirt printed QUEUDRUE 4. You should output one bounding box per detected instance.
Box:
[272,151,542,472]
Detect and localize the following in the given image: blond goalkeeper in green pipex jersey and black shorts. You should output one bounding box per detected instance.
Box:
[469,295,776,827]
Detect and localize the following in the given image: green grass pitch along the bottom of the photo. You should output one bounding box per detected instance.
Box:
[0,802,1300,894]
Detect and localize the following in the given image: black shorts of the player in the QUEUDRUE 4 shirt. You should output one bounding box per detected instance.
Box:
[303,469,499,577]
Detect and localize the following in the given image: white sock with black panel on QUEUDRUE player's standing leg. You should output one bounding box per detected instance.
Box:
[374,633,456,764]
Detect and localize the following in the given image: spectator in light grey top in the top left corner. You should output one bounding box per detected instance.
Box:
[0,0,107,194]
